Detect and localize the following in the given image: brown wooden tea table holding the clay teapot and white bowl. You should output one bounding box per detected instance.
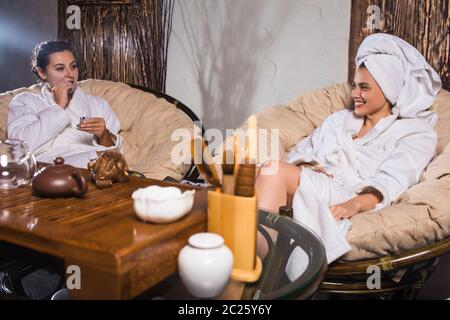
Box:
[0,171,206,299]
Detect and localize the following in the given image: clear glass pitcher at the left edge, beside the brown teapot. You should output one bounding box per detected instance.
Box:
[0,139,37,189]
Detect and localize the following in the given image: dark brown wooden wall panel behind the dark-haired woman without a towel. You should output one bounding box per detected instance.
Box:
[58,0,174,92]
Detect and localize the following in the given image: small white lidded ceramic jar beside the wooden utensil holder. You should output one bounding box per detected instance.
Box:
[178,232,233,298]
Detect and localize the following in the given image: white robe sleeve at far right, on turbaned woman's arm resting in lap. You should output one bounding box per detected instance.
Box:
[356,130,437,211]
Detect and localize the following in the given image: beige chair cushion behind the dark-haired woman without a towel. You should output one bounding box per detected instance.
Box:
[0,79,194,180]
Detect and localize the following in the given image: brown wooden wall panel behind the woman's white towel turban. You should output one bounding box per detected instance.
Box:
[349,0,450,90]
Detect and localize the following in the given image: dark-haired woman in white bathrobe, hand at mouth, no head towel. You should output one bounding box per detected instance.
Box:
[7,40,122,168]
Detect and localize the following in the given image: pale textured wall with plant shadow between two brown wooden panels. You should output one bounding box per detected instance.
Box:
[166,0,351,130]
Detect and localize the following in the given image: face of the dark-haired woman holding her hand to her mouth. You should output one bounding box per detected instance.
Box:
[38,50,78,92]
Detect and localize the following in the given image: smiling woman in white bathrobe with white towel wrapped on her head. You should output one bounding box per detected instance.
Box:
[256,34,441,263]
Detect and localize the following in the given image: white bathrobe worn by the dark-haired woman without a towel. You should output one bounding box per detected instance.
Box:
[7,85,122,168]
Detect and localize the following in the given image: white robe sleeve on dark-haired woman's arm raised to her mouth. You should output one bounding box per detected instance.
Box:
[7,94,71,152]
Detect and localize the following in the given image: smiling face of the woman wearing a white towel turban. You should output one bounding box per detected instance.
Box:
[352,67,391,117]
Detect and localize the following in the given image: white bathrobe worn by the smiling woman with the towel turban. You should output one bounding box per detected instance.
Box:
[288,108,437,263]
